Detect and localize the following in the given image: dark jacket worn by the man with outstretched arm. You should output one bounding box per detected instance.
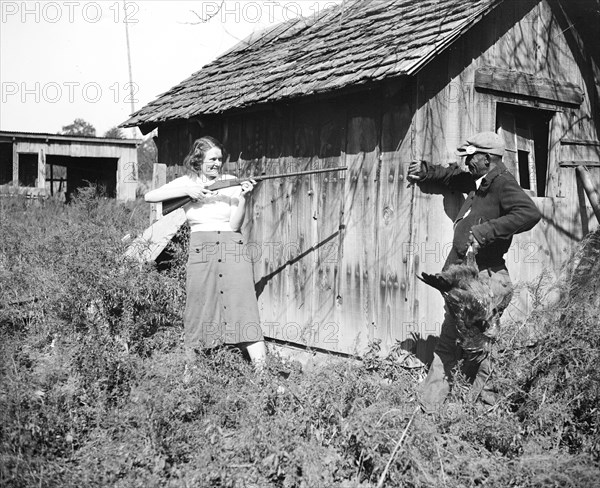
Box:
[421,162,541,270]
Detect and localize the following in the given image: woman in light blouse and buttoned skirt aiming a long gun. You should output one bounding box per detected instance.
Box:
[145,137,266,367]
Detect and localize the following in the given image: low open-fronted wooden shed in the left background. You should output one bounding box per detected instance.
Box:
[0,131,140,201]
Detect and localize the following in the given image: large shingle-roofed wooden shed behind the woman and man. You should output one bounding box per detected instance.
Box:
[124,0,600,359]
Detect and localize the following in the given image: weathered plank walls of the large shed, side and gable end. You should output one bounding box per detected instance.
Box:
[152,0,600,359]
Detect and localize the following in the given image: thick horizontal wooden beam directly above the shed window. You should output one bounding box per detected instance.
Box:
[475,66,583,105]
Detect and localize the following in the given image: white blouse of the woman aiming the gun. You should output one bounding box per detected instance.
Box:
[167,175,242,232]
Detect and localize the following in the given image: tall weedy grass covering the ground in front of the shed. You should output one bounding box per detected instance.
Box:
[0,192,600,488]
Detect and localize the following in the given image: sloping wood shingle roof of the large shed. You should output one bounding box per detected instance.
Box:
[123,0,500,127]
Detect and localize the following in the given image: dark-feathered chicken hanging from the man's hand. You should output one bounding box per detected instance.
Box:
[418,257,504,355]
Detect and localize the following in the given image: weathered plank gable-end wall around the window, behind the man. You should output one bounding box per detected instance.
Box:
[408,1,600,328]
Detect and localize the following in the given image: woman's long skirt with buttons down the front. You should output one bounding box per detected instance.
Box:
[183,231,263,348]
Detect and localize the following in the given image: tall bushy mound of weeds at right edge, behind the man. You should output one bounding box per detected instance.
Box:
[496,231,600,461]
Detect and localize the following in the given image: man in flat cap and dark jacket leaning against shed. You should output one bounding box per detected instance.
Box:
[407,132,541,412]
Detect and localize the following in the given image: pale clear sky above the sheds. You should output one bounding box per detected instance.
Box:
[0,0,343,137]
